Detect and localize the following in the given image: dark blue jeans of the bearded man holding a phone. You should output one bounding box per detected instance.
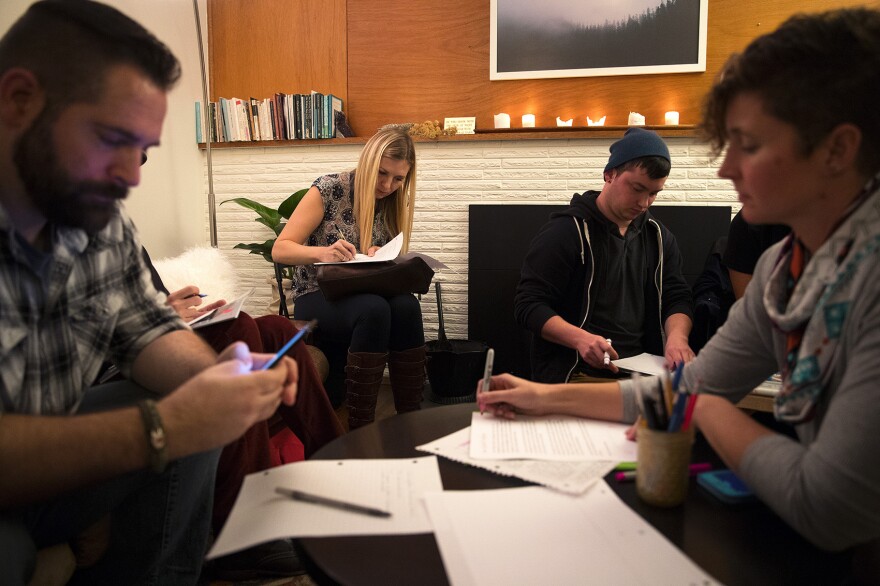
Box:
[0,382,220,586]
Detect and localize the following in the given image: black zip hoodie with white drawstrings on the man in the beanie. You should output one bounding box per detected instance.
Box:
[514,191,693,383]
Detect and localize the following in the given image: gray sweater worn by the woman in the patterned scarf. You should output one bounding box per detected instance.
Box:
[622,237,880,550]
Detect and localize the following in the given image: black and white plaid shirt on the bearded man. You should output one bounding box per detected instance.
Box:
[0,206,186,415]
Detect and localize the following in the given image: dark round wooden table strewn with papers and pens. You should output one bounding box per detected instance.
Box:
[297,403,850,586]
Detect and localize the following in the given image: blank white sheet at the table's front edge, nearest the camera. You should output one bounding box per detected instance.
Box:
[425,482,717,586]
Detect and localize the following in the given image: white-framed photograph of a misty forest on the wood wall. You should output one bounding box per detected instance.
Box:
[489,0,709,80]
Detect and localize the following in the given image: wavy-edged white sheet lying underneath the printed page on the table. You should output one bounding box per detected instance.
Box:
[416,427,617,494]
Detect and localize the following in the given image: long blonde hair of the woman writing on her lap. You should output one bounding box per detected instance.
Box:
[354,125,416,254]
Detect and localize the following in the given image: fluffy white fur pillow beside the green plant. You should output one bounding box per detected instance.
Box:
[153,246,238,303]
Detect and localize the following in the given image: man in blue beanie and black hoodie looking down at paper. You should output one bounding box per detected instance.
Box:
[514,128,694,383]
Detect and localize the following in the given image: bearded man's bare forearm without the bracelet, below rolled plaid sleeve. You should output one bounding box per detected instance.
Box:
[132,330,217,395]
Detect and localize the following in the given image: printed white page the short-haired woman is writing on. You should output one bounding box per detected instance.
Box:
[470,413,636,462]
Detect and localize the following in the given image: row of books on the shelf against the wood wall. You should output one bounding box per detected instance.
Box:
[196,91,342,143]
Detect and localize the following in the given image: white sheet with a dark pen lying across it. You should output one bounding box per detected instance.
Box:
[208,456,443,559]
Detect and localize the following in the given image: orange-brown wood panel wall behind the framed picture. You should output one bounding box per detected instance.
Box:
[209,0,857,136]
